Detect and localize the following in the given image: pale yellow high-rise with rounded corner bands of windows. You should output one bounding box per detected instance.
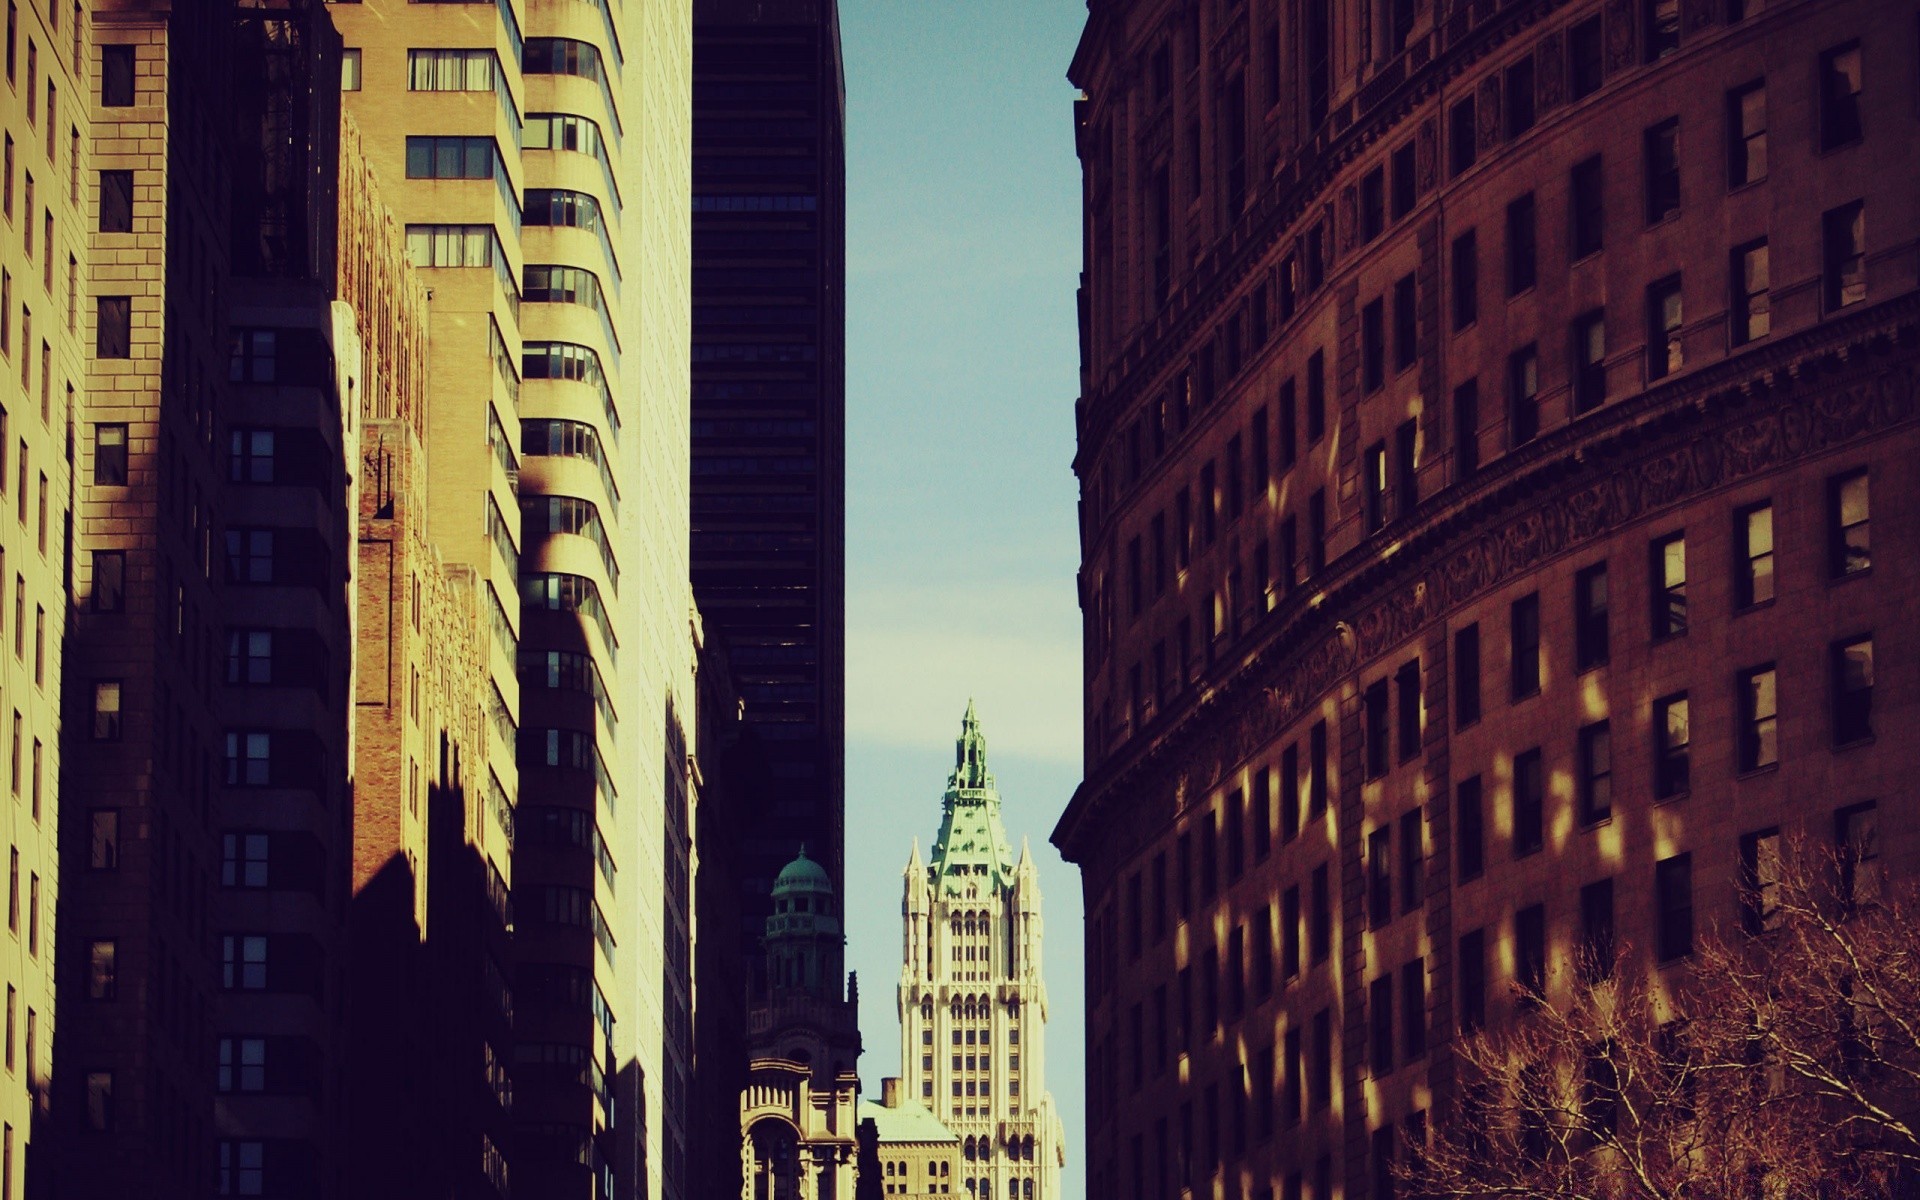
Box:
[332,0,697,1198]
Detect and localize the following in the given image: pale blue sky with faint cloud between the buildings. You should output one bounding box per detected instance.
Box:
[841,0,1087,1196]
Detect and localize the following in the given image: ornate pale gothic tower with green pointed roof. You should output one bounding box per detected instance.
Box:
[899,701,1066,1200]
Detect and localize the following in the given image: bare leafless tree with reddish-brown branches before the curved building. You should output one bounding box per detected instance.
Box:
[1396,847,1920,1200]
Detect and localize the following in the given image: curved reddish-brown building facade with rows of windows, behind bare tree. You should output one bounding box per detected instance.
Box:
[1054,0,1920,1200]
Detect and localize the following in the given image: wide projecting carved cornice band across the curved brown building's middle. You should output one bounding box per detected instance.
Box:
[1052,294,1920,862]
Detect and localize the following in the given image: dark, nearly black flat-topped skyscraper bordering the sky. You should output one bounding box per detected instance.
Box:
[693,0,847,936]
